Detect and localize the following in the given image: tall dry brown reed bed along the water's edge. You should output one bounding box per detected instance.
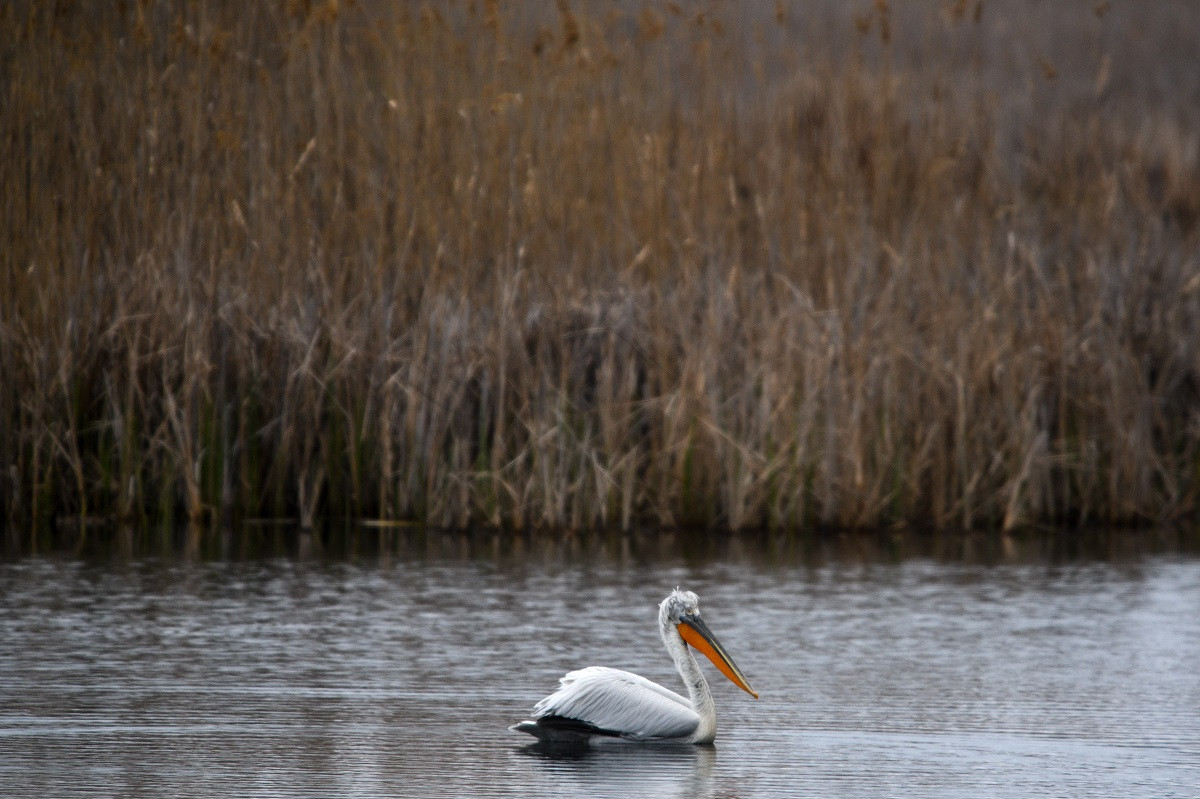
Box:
[0,0,1200,529]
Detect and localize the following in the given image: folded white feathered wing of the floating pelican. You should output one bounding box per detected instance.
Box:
[533,666,700,739]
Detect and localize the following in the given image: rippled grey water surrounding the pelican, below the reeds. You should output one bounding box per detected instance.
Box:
[0,525,1200,797]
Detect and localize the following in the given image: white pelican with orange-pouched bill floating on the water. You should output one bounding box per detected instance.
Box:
[509,588,758,744]
